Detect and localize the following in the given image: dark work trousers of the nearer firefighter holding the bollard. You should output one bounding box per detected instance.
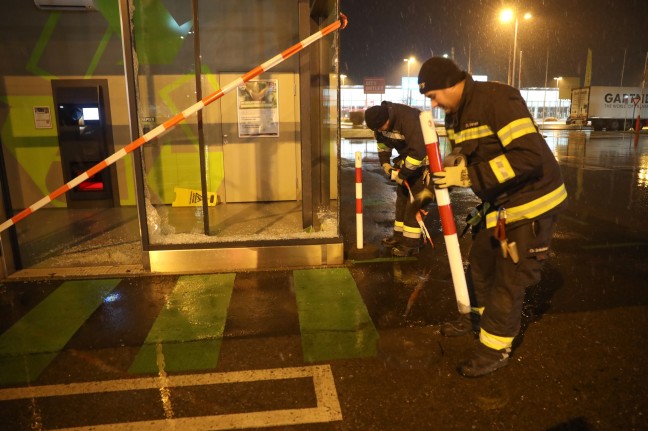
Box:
[468,216,557,337]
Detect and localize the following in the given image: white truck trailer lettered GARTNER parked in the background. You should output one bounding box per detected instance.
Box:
[567,86,648,131]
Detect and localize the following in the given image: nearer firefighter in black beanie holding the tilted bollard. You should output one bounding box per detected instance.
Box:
[418,57,567,377]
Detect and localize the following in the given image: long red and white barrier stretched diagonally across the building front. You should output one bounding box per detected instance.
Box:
[0,14,347,232]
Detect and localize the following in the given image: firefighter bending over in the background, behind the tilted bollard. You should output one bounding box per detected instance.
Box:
[365,101,433,256]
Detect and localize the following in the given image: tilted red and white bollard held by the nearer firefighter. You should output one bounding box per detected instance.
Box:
[419,111,470,314]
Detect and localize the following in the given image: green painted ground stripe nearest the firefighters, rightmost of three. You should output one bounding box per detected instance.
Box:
[293,268,378,362]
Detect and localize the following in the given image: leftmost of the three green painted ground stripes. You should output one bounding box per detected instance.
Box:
[0,279,121,384]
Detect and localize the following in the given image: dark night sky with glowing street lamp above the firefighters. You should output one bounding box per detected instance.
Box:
[340,0,648,91]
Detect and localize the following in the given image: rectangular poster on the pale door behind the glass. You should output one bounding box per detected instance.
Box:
[237,79,279,138]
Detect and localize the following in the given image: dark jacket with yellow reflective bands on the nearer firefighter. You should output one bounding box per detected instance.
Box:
[446,75,567,227]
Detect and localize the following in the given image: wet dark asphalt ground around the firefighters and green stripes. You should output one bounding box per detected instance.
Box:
[0,130,648,431]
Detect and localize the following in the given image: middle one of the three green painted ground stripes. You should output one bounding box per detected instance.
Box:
[128,274,236,374]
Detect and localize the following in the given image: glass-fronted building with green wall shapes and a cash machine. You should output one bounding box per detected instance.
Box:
[0,0,342,275]
